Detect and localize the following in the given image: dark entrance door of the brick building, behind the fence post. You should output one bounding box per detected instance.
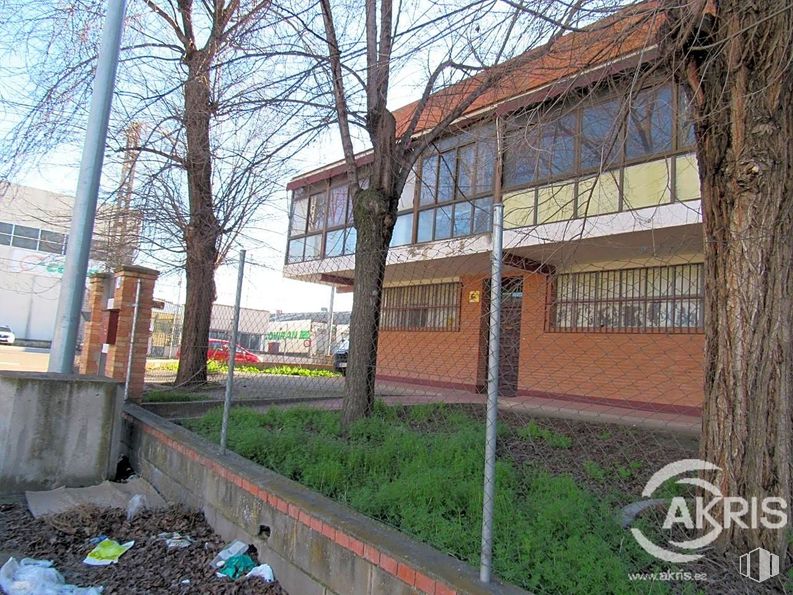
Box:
[479,277,523,397]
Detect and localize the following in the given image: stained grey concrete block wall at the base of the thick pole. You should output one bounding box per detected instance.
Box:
[0,372,121,494]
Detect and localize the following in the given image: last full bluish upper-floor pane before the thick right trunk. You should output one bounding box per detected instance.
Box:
[625,85,674,159]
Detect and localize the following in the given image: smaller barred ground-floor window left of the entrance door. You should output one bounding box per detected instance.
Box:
[380,283,462,331]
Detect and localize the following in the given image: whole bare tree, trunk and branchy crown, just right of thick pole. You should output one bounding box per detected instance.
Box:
[2,0,324,384]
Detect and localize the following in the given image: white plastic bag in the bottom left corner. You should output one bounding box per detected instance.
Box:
[0,558,102,595]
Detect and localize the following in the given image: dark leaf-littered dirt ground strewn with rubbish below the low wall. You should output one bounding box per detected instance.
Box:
[0,502,286,595]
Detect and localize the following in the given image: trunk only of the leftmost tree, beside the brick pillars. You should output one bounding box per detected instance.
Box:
[176,51,221,385]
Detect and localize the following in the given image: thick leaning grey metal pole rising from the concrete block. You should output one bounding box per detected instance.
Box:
[48,0,126,374]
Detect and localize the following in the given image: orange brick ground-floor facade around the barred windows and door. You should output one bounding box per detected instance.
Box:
[378,270,704,412]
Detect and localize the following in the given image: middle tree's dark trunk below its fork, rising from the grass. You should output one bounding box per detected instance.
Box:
[342,188,397,428]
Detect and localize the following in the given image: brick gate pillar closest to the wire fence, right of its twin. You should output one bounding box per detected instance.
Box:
[105,266,159,402]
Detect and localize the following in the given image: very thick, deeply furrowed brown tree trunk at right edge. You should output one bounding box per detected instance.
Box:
[685,0,793,556]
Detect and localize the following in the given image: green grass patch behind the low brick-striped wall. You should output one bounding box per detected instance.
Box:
[186,403,667,593]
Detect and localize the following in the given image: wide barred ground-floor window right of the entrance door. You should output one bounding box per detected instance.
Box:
[547,264,704,332]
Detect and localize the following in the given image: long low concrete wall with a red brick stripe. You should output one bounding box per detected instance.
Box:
[124,405,523,595]
